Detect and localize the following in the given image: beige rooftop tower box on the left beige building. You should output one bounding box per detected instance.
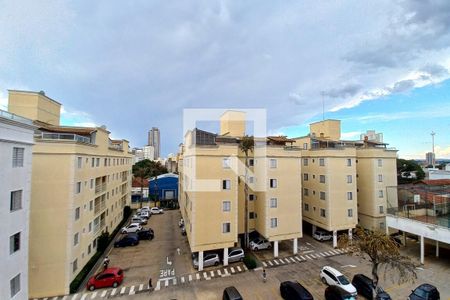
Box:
[8,90,61,125]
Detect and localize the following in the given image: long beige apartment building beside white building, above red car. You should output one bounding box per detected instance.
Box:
[9,90,132,298]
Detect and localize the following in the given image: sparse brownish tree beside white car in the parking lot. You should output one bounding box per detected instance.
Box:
[339,227,417,299]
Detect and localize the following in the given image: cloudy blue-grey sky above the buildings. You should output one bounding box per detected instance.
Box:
[0,0,450,158]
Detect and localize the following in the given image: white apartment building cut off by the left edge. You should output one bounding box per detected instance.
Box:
[0,110,36,299]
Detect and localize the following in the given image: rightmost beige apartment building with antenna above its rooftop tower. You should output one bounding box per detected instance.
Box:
[295,120,397,247]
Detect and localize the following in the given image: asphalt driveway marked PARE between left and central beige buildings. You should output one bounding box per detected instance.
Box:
[109,210,195,286]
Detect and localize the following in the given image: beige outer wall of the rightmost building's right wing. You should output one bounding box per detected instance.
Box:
[356,148,397,231]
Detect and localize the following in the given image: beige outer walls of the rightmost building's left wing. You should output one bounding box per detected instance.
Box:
[302,148,358,231]
